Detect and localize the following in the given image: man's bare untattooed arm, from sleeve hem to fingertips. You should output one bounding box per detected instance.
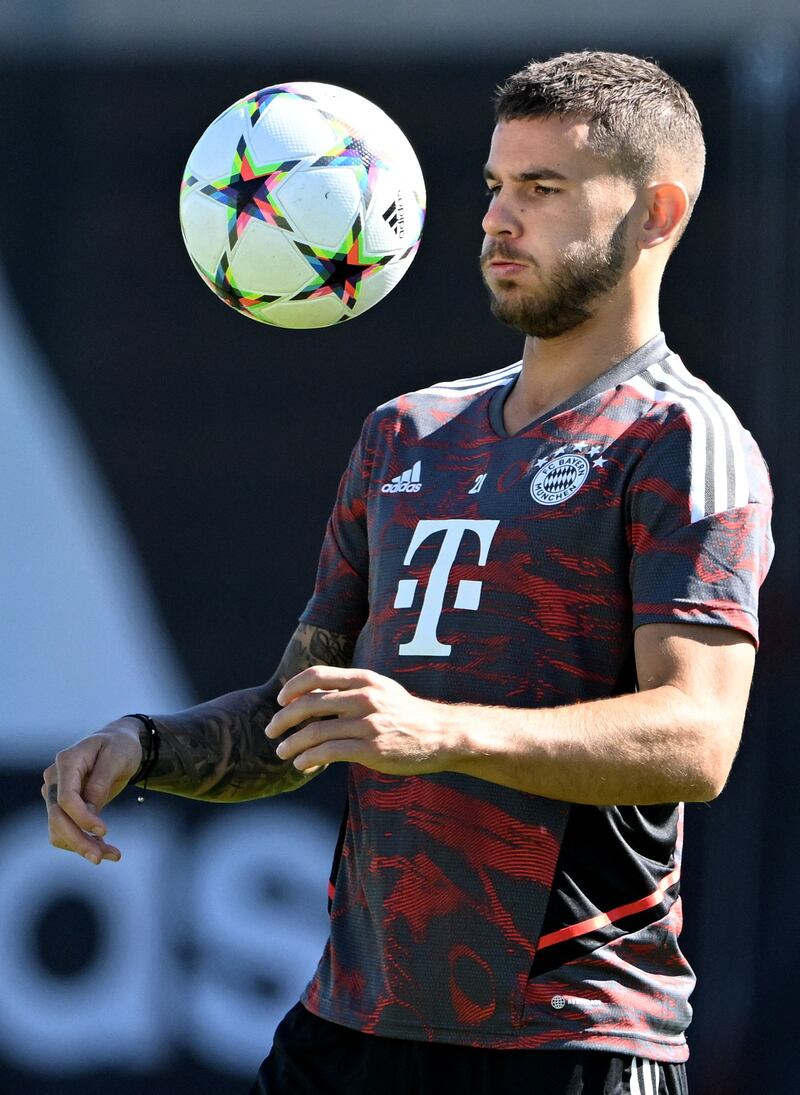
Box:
[267,624,754,806]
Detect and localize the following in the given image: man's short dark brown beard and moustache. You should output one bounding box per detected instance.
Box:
[480,217,627,338]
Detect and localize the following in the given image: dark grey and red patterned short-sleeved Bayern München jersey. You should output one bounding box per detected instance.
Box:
[302,336,772,1061]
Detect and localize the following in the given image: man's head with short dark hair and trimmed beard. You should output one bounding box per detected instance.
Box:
[483,51,705,338]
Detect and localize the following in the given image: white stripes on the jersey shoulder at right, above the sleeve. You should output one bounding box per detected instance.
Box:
[629,357,750,521]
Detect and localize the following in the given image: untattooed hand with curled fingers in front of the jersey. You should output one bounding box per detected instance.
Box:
[265,666,455,775]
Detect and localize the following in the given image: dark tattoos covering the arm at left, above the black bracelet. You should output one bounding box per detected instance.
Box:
[137,623,356,803]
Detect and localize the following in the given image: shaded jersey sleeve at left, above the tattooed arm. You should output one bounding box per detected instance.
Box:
[300,419,370,638]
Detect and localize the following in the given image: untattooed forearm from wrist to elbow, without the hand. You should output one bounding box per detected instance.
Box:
[444,685,741,806]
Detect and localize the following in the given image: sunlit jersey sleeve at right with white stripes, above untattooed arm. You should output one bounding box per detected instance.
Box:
[627,410,773,644]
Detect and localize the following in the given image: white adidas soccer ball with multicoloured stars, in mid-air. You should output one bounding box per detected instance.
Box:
[181,83,425,327]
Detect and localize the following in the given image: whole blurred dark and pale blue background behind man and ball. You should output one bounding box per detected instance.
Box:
[0,0,800,1095]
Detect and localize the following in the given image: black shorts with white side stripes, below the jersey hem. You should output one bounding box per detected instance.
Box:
[251,1004,688,1095]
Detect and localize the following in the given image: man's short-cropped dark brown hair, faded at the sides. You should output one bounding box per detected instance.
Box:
[495,49,706,210]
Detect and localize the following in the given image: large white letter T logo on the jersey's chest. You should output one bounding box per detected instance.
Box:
[394,520,500,656]
